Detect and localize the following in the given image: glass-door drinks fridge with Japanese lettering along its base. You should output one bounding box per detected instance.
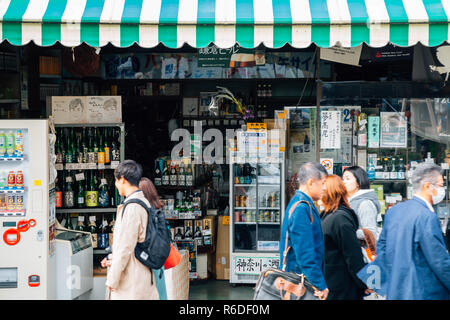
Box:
[230,153,285,283]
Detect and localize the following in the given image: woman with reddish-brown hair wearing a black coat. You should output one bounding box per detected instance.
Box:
[322,175,370,300]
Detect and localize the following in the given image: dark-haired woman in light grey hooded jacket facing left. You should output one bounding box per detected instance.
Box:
[342,166,381,240]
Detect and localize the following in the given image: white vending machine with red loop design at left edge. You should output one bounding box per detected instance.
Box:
[0,120,56,300]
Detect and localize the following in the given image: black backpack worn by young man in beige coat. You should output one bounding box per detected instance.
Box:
[122,199,171,284]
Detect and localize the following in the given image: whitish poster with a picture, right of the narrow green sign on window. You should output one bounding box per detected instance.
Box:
[380,112,408,148]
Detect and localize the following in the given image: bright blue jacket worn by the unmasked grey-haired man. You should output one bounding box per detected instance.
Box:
[280,191,327,290]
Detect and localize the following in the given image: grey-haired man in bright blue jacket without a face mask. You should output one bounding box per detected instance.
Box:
[280,162,328,299]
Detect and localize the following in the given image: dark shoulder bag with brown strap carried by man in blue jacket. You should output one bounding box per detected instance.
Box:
[253,200,323,300]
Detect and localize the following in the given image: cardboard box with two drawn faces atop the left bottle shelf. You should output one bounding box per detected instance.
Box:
[47,96,122,124]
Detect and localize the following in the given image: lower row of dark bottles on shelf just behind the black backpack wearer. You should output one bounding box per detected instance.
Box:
[161,190,202,219]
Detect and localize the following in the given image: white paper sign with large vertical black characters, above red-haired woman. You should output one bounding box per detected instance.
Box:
[320,111,341,149]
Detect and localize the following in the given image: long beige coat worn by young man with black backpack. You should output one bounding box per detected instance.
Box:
[106,191,159,300]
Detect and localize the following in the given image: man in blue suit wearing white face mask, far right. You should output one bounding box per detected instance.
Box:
[358,163,450,300]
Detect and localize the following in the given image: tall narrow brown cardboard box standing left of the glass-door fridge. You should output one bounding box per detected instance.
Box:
[216,216,230,280]
